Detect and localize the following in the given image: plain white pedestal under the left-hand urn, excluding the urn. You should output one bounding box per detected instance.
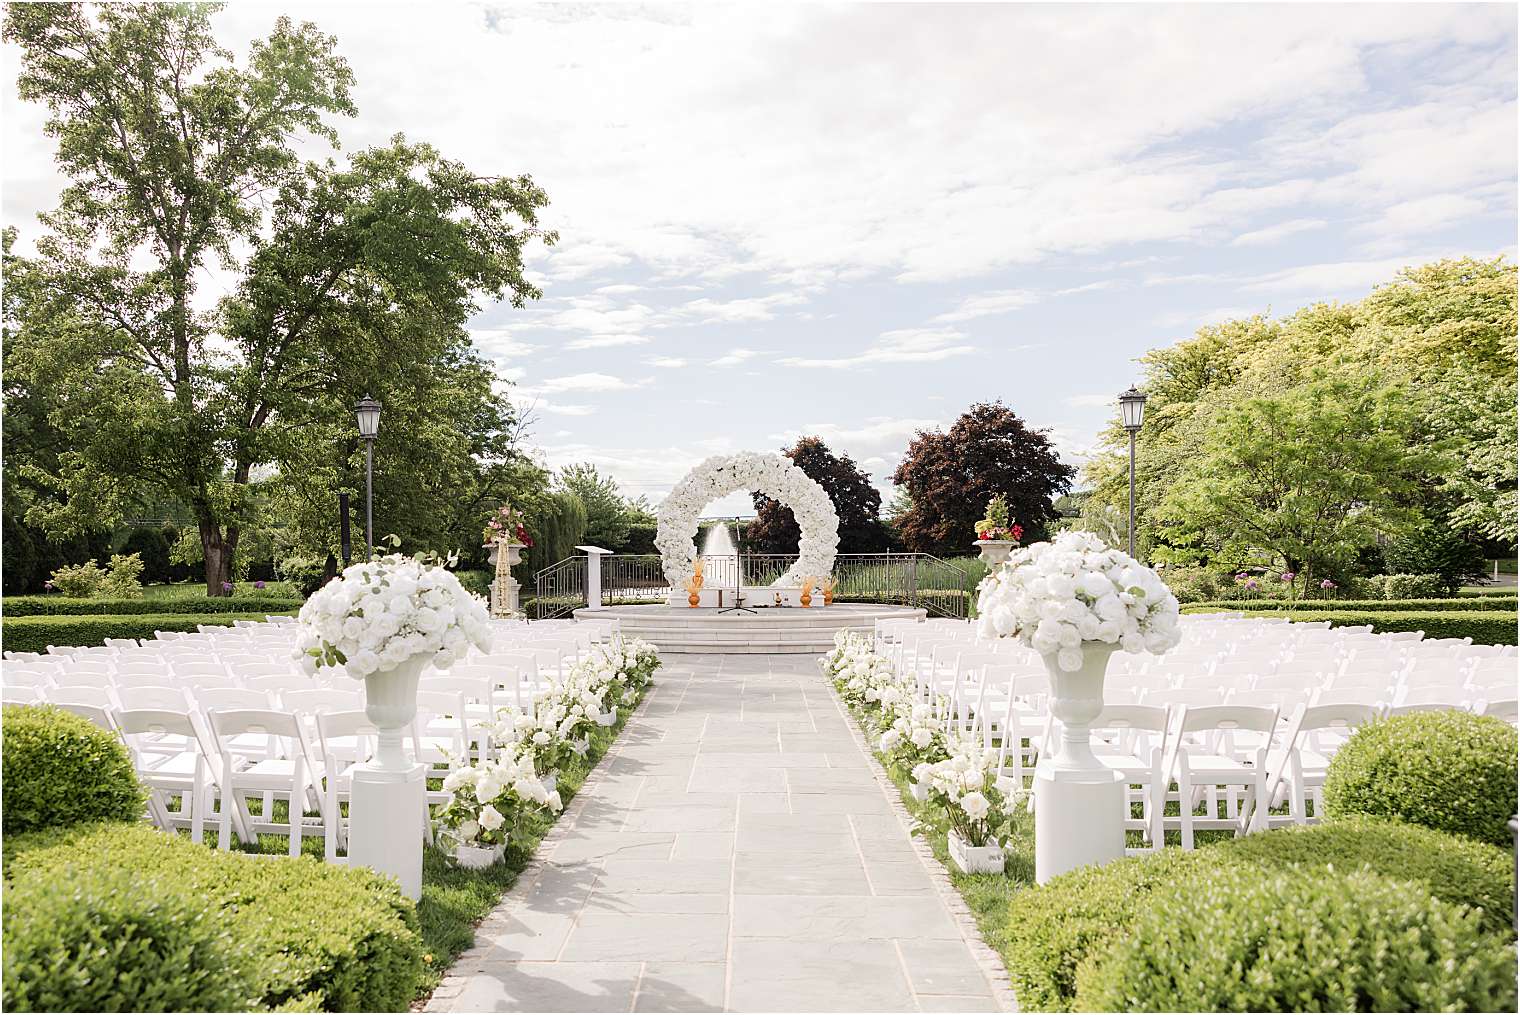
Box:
[348,764,427,900]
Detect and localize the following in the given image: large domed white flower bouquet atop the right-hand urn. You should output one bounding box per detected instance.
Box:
[976,532,1183,673]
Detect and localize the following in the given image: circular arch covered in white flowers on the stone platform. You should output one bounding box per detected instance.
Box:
[655,451,839,588]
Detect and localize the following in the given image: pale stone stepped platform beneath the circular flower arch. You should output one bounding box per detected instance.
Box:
[575,603,924,655]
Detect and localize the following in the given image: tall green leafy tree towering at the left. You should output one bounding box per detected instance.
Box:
[5,3,553,594]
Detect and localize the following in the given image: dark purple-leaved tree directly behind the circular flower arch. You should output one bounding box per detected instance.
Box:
[745,438,886,553]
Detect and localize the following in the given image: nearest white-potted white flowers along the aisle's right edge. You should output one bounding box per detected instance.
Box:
[921,737,1012,874]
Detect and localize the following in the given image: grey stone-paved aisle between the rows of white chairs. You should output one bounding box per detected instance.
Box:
[429,655,1006,1012]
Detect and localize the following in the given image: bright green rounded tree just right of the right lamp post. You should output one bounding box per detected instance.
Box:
[1158,375,1441,587]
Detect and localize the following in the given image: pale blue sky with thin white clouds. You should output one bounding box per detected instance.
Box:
[0,3,1517,515]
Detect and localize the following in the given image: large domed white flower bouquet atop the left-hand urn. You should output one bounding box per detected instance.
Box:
[296,555,491,679]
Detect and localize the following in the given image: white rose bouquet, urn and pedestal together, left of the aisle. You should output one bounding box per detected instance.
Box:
[296,555,491,898]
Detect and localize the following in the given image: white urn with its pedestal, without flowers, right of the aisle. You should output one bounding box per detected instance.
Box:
[1034,641,1125,884]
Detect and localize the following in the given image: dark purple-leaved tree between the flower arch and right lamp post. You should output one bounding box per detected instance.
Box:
[892,401,1076,555]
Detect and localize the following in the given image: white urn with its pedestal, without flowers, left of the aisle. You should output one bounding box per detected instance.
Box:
[348,655,427,900]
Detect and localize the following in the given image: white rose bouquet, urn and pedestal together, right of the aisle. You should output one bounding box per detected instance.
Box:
[977,532,1181,884]
